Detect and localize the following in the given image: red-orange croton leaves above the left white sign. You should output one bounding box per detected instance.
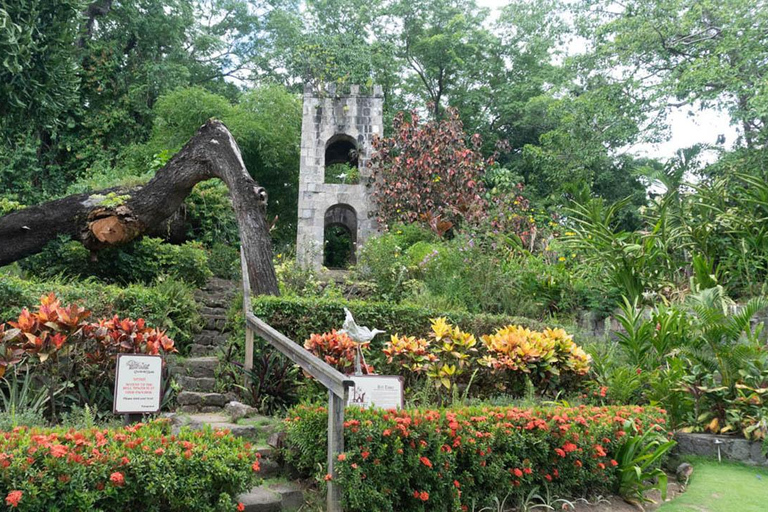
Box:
[0,293,176,377]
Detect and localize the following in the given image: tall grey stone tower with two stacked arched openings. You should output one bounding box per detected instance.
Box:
[296,84,384,269]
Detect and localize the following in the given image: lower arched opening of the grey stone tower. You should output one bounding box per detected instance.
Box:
[323,204,357,269]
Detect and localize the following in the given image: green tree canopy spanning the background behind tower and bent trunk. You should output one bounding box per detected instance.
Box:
[0,0,768,240]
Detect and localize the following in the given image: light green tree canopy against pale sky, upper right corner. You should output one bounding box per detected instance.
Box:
[580,0,768,146]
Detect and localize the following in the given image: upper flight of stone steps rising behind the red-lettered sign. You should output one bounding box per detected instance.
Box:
[171,278,238,413]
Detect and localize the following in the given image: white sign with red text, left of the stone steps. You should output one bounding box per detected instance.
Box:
[113,354,163,414]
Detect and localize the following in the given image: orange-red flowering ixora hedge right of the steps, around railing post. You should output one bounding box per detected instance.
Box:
[286,406,665,512]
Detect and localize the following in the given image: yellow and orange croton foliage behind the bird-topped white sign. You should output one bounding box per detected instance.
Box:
[304,317,590,403]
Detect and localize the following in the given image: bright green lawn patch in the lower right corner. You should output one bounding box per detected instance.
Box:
[658,459,768,512]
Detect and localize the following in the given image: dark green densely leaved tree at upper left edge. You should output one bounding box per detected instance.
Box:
[0,0,83,200]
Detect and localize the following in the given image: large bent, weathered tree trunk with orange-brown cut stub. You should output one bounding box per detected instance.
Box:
[0,120,279,295]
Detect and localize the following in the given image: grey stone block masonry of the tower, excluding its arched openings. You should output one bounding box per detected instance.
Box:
[296,85,384,269]
